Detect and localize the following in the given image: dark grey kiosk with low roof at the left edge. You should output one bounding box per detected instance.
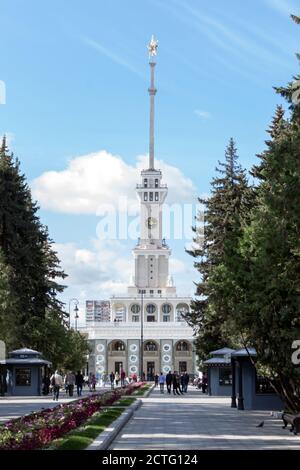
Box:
[0,348,51,396]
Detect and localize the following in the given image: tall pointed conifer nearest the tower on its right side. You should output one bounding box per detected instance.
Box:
[186,139,252,359]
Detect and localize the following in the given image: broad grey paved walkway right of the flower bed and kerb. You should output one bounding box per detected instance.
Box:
[110,389,300,450]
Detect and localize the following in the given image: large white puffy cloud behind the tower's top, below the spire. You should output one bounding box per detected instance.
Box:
[31,150,196,214]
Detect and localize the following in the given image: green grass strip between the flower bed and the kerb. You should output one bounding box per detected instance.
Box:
[50,407,124,450]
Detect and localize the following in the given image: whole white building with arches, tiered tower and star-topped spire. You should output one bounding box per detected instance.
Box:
[82,38,196,379]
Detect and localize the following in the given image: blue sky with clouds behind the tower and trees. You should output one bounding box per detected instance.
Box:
[0,0,300,324]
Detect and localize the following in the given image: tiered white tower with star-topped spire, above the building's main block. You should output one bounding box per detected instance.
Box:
[128,36,176,295]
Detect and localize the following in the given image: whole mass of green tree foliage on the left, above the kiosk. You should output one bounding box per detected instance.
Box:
[0,138,88,369]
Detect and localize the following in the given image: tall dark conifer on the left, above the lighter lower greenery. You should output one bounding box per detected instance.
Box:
[0,138,65,346]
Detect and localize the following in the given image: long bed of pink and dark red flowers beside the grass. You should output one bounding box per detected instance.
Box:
[0,382,144,450]
